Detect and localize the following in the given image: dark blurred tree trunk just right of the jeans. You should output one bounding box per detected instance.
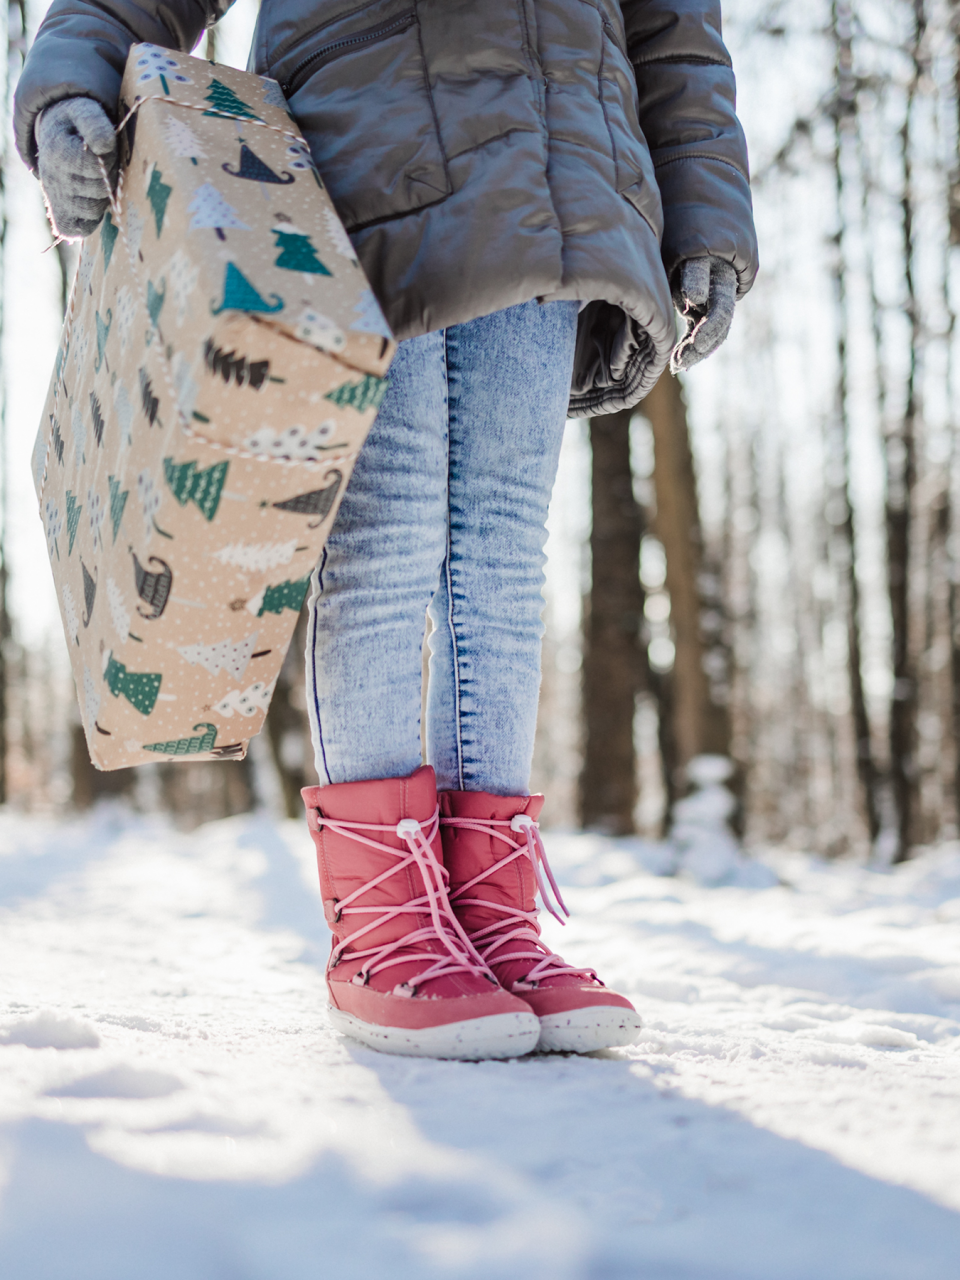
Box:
[580,410,645,835]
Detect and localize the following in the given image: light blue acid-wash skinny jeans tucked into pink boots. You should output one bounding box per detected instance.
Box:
[307,302,579,795]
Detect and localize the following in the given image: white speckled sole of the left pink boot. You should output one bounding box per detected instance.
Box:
[326,1006,541,1061]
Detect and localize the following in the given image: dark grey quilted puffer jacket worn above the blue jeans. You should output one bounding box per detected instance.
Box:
[15,0,756,415]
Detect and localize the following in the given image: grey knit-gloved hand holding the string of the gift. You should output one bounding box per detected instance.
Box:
[36,97,118,239]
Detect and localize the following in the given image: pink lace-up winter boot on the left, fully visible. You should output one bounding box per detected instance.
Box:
[302,765,540,1059]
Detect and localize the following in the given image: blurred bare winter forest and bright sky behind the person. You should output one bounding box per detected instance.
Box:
[0,0,960,861]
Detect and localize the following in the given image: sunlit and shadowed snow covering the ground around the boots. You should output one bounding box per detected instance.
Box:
[0,808,960,1280]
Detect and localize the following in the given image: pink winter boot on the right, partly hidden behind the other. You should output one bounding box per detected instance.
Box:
[440,791,640,1053]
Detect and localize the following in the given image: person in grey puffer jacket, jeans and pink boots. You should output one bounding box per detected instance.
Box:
[15,0,756,1057]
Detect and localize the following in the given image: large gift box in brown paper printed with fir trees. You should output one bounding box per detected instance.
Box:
[35,45,394,769]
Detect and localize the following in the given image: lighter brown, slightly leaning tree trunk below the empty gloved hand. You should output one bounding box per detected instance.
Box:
[643,372,730,786]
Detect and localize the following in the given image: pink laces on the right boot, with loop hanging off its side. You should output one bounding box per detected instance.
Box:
[440,813,600,991]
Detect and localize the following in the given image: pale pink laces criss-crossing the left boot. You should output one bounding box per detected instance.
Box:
[317,808,497,996]
